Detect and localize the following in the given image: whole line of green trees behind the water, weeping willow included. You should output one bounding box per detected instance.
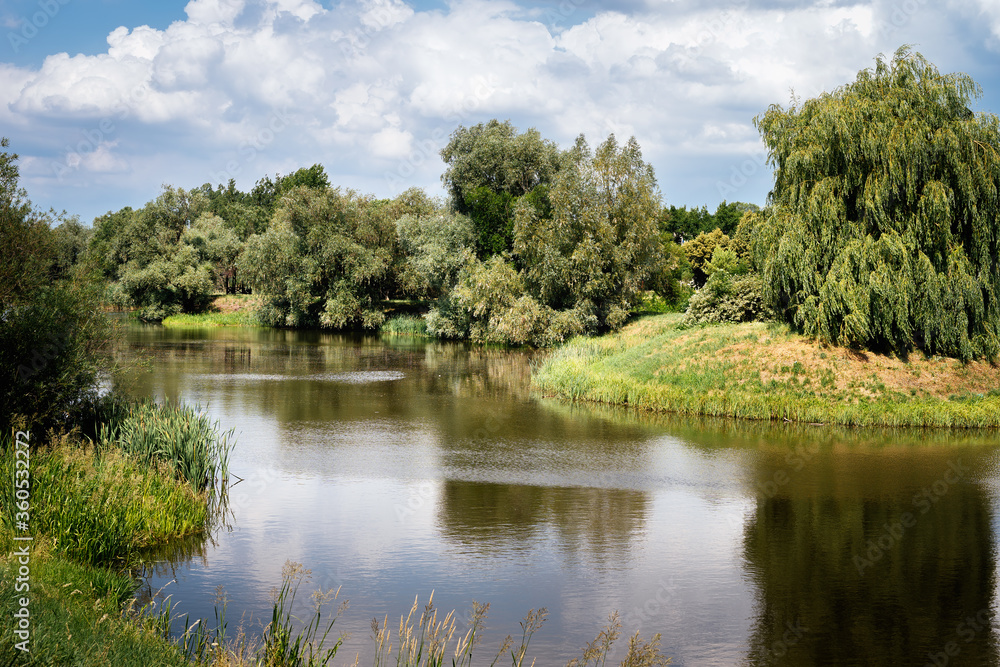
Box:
[4,47,1000,380]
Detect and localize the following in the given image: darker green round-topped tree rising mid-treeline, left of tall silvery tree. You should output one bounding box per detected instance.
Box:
[441,119,560,258]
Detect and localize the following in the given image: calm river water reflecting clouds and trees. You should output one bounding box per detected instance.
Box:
[130,327,1000,665]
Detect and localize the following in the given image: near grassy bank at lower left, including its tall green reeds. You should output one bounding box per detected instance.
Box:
[0,399,228,666]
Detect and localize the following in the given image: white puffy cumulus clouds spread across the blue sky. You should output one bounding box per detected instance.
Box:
[0,0,1000,222]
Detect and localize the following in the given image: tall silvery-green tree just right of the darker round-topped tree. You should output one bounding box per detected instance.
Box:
[514,135,663,331]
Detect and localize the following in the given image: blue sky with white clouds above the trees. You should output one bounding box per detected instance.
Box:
[0,0,1000,224]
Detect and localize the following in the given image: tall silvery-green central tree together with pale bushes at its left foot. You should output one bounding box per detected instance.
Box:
[428,135,663,345]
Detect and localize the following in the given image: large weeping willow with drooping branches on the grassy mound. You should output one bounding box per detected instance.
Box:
[745,47,1000,359]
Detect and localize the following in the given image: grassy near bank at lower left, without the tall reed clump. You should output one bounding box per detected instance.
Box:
[0,426,210,667]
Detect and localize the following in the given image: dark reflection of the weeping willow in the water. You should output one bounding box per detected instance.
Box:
[743,440,998,665]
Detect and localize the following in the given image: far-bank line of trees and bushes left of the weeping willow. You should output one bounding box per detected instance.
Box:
[70,120,757,345]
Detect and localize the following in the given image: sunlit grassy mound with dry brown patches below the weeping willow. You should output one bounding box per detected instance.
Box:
[533,314,1000,428]
